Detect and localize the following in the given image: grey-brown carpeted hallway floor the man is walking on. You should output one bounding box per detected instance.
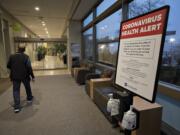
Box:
[0,74,120,135]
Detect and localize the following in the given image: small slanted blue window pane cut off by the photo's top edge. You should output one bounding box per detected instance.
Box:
[97,0,117,16]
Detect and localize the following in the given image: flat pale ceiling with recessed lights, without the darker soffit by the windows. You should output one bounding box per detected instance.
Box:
[0,0,73,38]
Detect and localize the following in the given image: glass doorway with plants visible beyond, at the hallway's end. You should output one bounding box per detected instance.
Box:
[16,42,67,70]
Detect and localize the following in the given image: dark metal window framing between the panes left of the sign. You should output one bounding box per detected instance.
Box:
[81,0,132,67]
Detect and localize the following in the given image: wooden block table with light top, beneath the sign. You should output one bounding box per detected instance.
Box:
[131,96,162,135]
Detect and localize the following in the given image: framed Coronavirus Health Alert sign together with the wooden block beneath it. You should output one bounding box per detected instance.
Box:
[115,6,169,135]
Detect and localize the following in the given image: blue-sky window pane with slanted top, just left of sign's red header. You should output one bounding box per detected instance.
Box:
[96,10,121,42]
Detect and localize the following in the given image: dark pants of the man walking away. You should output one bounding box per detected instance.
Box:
[13,79,33,109]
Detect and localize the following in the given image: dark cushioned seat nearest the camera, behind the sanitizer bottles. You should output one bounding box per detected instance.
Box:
[94,87,132,123]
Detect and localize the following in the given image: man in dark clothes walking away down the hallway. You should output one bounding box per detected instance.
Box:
[7,46,34,113]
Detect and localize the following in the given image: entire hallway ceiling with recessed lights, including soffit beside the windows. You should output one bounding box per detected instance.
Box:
[0,0,98,38]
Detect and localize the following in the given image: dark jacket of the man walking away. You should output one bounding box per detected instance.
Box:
[7,53,34,81]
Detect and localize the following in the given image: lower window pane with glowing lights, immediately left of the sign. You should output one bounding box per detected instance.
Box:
[98,42,118,66]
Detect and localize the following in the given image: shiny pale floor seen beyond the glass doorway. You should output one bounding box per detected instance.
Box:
[32,55,67,70]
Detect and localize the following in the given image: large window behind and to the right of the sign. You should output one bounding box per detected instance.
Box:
[129,0,180,86]
